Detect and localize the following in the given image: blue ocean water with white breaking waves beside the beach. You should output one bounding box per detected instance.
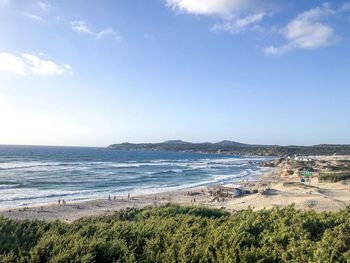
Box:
[0,145,274,208]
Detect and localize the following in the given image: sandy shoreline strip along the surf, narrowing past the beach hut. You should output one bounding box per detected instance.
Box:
[0,167,274,222]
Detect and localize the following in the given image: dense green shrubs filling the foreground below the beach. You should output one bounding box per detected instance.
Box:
[0,205,350,262]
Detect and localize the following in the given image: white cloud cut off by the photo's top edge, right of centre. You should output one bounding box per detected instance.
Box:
[166,0,270,33]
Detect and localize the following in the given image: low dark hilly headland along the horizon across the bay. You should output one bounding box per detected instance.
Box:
[107,140,350,156]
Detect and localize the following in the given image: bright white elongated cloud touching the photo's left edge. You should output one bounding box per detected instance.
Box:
[0,52,72,75]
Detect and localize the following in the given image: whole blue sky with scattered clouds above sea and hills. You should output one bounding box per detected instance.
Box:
[0,0,350,146]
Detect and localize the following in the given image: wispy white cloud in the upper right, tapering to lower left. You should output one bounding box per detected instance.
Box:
[264,4,336,54]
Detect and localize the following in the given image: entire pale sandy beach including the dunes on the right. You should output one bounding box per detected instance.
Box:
[0,156,350,222]
